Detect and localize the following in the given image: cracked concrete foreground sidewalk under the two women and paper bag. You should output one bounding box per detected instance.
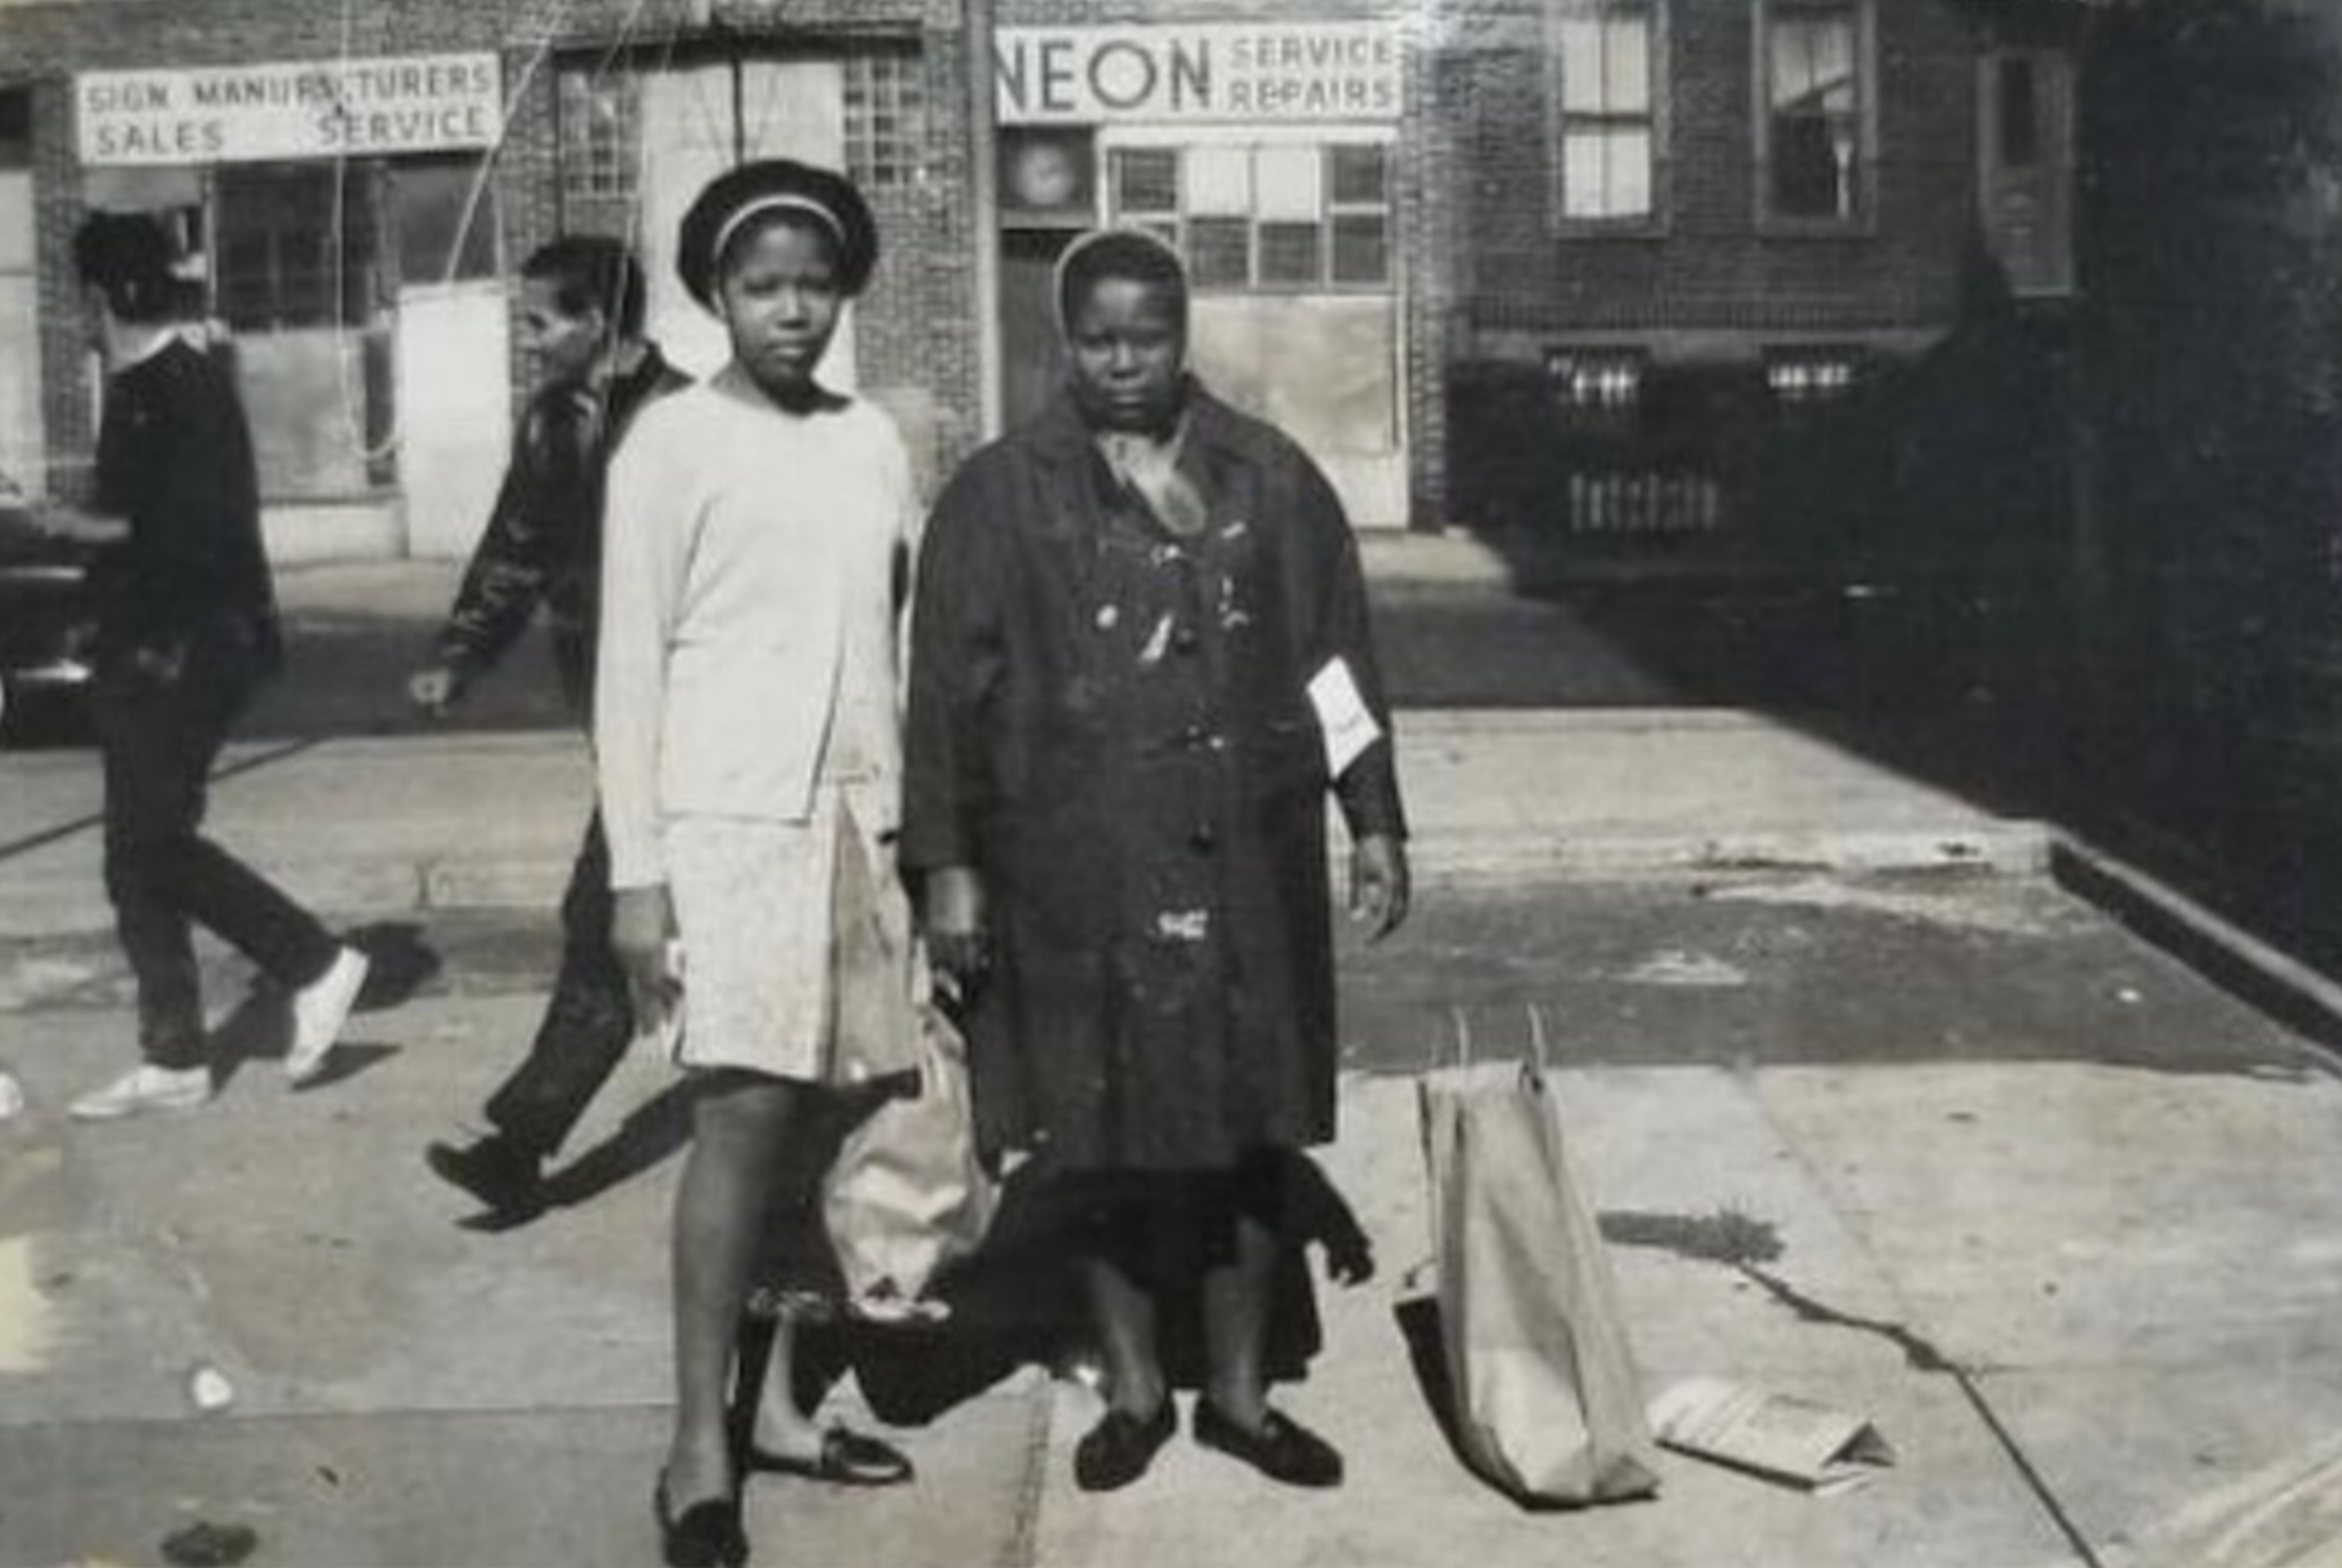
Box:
[0,876,2342,1568]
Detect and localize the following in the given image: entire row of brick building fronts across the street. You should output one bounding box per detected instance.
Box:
[0,0,2070,556]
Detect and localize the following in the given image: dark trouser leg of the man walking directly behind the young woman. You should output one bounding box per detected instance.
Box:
[487,811,635,1158]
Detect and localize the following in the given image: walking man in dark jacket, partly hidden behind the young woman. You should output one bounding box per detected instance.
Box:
[408,237,686,1219]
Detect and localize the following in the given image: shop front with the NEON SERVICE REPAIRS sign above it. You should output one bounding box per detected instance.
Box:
[993,0,1445,527]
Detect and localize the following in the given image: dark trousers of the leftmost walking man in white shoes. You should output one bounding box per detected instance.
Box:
[91,628,339,1071]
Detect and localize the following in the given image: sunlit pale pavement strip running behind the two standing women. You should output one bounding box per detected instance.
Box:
[0,711,2047,935]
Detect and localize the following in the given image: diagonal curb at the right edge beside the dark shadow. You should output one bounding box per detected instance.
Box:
[2049,832,2342,1055]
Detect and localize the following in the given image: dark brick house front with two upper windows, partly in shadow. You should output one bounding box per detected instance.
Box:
[1429,0,2073,549]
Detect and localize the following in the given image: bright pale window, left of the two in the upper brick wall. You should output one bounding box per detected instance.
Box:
[1550,0,1663,225]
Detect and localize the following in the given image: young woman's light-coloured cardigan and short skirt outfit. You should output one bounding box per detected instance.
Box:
[594,365,920,1081]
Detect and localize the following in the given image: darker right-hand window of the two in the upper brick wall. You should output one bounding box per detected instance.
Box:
[1756,0,1872,222]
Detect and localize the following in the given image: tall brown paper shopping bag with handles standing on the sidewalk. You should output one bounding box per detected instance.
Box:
[1419,1012,1658,1504]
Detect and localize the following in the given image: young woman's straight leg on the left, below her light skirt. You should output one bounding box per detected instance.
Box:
[665,1074,806,1509]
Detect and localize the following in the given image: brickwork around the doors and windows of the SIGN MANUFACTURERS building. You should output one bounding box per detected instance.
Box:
[0,0,978,508]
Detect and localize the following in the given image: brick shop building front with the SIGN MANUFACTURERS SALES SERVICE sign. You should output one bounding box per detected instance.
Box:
[0,0,981,558]
